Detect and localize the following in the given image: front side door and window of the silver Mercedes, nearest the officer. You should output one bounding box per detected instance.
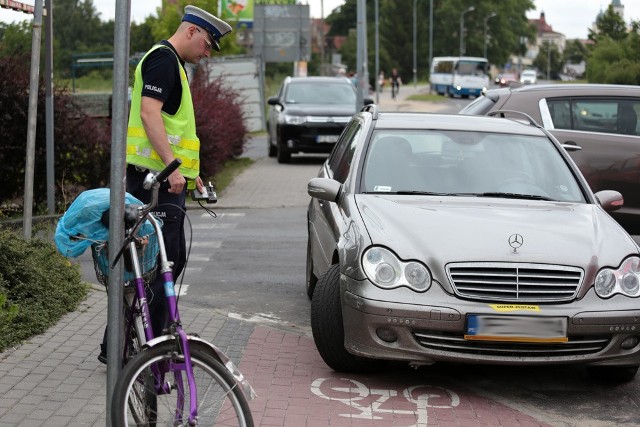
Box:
[309,116,363,274]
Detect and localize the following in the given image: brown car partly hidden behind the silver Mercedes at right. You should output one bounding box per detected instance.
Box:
[460,84,640,235]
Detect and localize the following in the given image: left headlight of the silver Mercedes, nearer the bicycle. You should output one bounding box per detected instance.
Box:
[362,246,431,292]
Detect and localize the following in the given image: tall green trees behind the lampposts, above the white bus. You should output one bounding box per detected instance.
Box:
[327,0,535,81]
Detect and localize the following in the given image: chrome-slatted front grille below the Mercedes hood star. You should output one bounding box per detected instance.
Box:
[447,262,584,302]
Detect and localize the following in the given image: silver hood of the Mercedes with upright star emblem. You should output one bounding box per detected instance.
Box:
[356,195,638,266]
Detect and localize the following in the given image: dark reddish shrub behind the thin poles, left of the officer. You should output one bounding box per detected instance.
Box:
[0,56,111,214]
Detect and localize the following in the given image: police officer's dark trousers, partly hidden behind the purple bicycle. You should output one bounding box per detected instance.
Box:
[101,165,186,353]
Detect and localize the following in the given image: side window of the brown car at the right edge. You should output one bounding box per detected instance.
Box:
[547,99,640,135]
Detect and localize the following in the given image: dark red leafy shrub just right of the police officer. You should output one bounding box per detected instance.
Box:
[191,64,247,177]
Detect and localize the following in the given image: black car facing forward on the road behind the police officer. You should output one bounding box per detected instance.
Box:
[267,77,356,163]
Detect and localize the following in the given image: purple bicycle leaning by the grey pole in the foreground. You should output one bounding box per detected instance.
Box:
[102,159,255,427]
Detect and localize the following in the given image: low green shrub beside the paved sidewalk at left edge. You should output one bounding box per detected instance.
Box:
[0,230,88,351]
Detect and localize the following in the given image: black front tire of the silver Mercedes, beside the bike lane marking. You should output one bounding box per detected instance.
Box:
[311,264,386,373]
